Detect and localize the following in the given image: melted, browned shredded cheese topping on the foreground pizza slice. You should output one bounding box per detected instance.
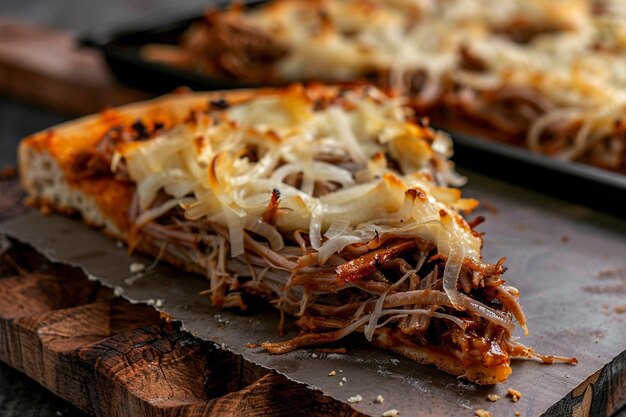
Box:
[114,88,481,278]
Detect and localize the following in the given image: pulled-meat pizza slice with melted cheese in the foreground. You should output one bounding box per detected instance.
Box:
[19,85,575,384]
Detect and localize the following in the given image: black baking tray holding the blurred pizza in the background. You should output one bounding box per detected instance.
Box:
[81,9,626,216]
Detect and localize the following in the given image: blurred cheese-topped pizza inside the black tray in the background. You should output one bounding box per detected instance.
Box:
[142,0,626,173]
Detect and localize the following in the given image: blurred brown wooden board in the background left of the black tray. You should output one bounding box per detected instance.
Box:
[0,17,149,116]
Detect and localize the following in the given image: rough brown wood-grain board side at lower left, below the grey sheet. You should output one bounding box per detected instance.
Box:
[0,240,358,417]
